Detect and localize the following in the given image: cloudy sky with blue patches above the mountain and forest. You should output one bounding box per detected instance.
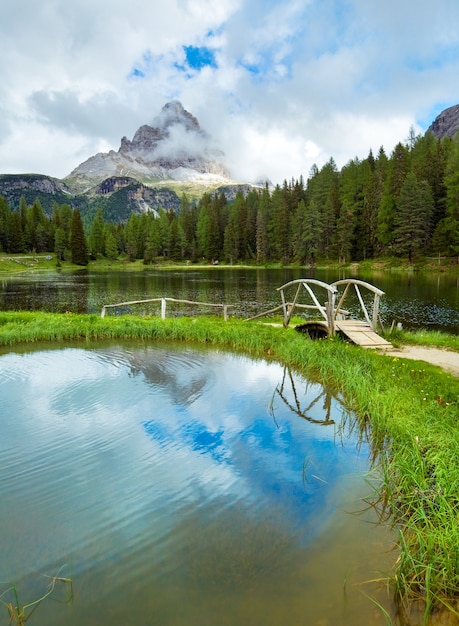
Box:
[0,0,459,184]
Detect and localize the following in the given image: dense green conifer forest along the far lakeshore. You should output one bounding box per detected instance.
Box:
[0,130,459,265]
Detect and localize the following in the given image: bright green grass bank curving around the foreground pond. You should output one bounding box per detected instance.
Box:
[0,312,459,611]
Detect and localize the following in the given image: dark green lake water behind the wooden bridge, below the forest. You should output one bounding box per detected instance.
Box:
[0,269,459,333]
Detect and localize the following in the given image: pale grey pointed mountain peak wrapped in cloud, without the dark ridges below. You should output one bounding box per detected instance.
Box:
[63,100,230,193]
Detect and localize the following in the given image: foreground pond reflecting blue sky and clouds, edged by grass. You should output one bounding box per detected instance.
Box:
[0,343,396,626]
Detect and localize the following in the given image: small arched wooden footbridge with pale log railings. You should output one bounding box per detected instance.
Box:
[246,278,392,349]
